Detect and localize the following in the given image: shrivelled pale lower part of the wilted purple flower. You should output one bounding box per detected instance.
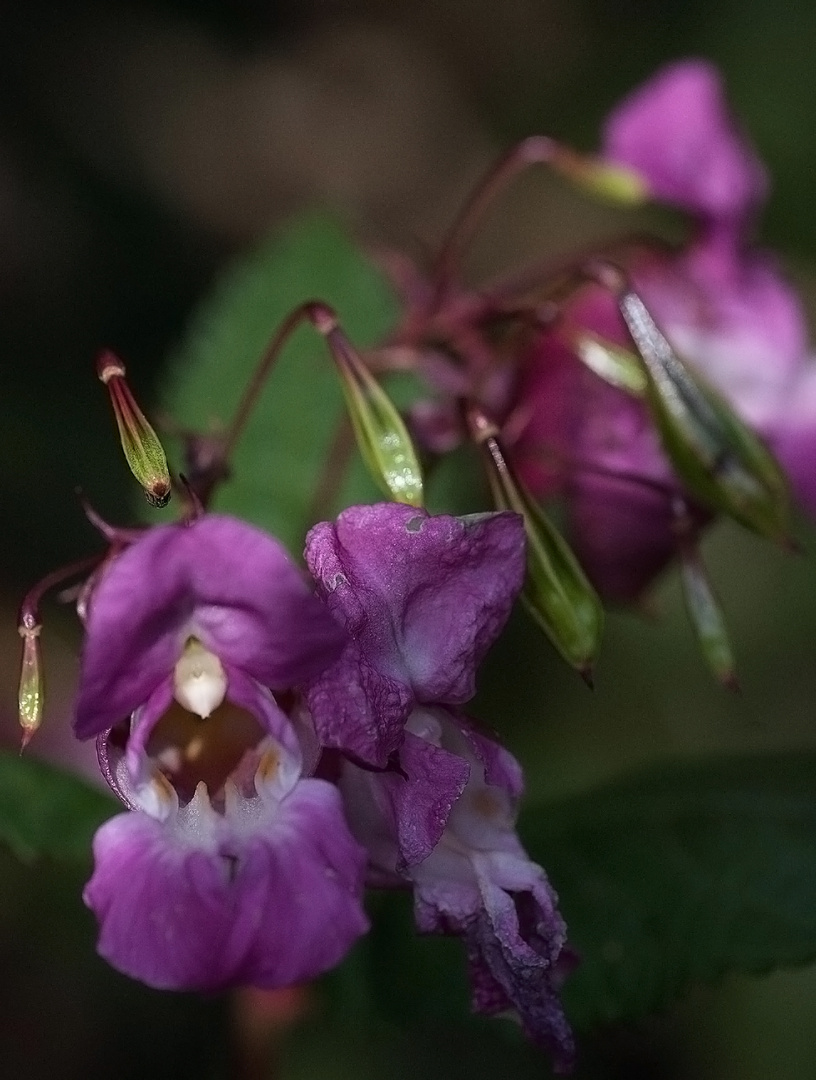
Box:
[340,708,574,1072]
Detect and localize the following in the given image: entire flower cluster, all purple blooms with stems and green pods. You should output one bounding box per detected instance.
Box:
[19,54,816,1071]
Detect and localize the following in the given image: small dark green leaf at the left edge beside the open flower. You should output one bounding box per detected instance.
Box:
[0,751,119,863]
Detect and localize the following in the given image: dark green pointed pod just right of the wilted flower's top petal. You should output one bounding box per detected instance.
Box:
[467,407,603,684]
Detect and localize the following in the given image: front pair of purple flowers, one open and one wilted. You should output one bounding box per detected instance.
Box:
[68,504,572,1069]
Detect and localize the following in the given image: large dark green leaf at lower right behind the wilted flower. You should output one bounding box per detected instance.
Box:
[521,752,816,1027]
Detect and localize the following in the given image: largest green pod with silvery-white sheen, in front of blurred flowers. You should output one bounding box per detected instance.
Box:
[613,286,788,543]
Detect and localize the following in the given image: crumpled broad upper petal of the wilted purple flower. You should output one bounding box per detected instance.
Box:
[305,503,525,766]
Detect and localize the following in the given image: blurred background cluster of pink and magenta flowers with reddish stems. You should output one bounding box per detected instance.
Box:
[379,60,816,617]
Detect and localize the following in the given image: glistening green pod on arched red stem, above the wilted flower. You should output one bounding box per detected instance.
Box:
[311,303,424,507]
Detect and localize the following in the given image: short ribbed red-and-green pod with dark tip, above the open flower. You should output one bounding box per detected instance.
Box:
[96,352,171,508]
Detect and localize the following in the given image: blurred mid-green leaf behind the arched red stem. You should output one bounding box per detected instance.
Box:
[163,216,396,554]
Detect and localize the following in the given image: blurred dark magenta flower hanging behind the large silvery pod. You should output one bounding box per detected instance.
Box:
[514,300,707,603]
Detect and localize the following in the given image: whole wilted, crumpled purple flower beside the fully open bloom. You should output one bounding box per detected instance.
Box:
[307,505,573,1069]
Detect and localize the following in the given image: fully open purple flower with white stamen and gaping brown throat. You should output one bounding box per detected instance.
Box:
[76,516,367,989]
